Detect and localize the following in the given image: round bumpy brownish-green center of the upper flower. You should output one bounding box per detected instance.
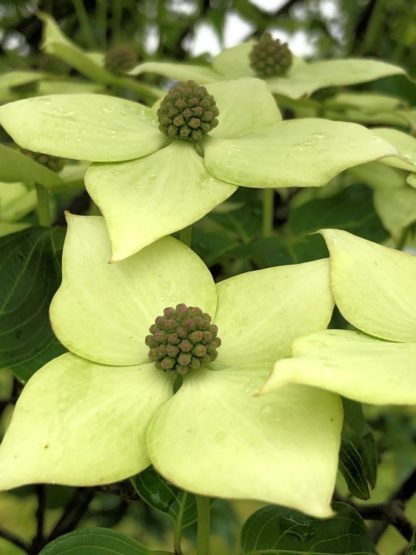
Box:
[157,81,219,142]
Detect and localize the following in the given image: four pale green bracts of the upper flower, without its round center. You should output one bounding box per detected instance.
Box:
[0,78,398,261]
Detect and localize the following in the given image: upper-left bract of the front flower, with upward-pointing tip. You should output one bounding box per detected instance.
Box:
[50,216,217,366]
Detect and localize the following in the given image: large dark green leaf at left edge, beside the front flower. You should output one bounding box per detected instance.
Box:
[0,227,63,381]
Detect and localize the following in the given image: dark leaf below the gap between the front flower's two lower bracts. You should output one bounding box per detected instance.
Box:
[131,467,197,528]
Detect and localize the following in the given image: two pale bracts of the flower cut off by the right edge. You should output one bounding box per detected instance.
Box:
[260,230,416,404]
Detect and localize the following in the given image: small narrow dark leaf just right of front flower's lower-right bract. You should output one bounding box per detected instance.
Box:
[339,440,370,499]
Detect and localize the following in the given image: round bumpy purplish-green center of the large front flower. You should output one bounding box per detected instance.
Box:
[145,304,221,377]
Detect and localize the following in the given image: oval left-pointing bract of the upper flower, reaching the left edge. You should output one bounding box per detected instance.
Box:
[0,94,167,162]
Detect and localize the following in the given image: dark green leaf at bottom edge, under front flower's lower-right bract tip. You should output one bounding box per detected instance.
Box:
[241,503,376,555]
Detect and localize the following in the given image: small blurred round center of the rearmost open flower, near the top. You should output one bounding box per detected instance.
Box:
[249,33,293,78]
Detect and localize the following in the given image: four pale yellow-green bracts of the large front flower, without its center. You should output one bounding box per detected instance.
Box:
[0,216,342,517]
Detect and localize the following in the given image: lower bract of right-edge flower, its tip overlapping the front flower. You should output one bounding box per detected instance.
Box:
[260,330,416,405]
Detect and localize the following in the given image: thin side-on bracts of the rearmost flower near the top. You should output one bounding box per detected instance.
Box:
[129,41,406,98]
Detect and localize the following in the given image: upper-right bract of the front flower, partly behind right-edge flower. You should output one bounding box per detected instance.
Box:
[214,259,334,369]
